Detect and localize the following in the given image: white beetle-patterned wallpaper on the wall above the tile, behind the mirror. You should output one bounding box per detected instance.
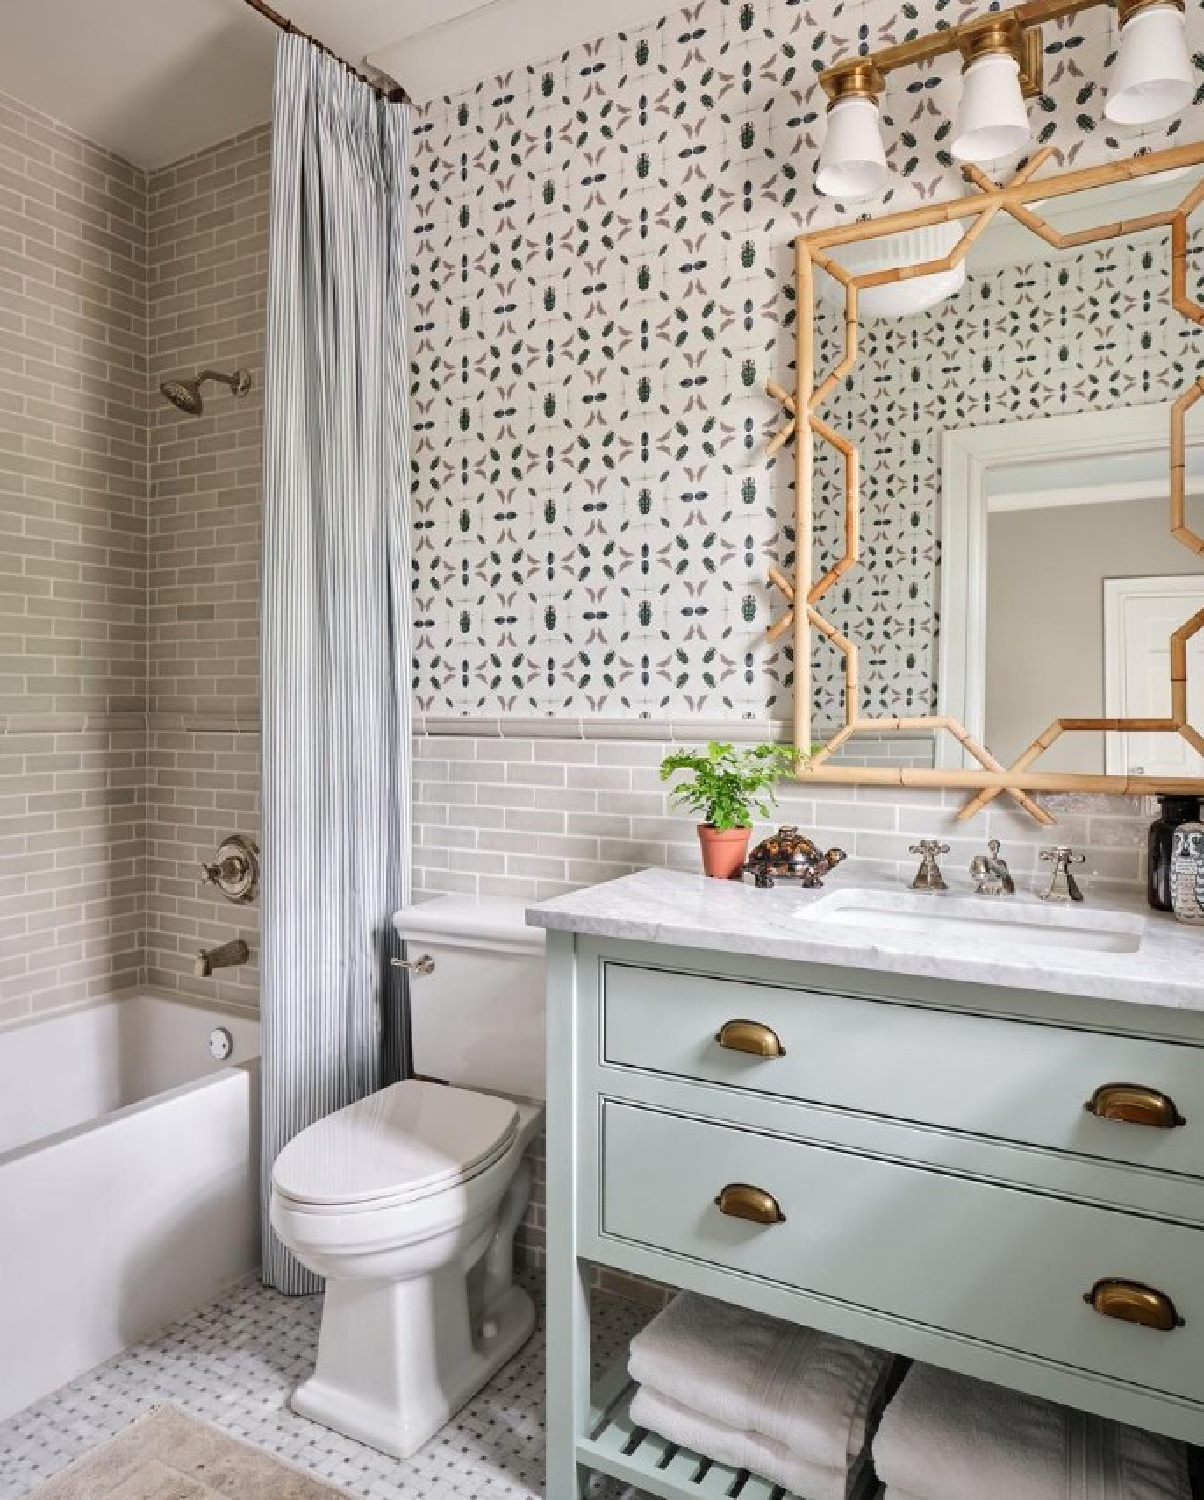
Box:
[411,0,1204,719]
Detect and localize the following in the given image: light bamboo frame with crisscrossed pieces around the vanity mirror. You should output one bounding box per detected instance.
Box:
[766,143,1204,824]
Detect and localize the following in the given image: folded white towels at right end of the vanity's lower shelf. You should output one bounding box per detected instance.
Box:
[874,1365,1191,1500]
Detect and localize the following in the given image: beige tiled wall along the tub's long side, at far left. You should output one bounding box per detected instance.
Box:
[0,98,147,1023]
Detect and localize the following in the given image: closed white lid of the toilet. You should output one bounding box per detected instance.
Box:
[271,1080,519,1205]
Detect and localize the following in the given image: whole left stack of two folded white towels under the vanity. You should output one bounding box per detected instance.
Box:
[627,1292,893,1500]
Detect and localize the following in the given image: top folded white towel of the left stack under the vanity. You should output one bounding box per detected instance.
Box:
[627,1292,894,1472]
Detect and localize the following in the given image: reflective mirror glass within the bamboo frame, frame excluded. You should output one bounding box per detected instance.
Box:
[811,168,1204,776]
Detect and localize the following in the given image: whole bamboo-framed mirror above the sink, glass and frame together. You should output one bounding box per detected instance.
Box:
[769,144,1204,822]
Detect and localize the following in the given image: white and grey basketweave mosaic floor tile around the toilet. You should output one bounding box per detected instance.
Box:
[0,1280,652,1500]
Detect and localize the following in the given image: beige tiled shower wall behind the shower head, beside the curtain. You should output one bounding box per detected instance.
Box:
[145,128,271,1007]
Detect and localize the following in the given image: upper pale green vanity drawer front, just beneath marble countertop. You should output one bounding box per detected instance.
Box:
[603,962,1204,1178]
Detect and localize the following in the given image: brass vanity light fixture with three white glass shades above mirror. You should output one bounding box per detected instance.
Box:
[816,0,1195,203]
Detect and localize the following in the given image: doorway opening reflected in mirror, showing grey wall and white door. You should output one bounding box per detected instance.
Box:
[985,447,1204,776]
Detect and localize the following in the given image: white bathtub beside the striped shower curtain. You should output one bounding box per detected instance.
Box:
[0,995,259,1421]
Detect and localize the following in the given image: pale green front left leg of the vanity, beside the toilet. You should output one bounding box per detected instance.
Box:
[544,932,589,1500]
